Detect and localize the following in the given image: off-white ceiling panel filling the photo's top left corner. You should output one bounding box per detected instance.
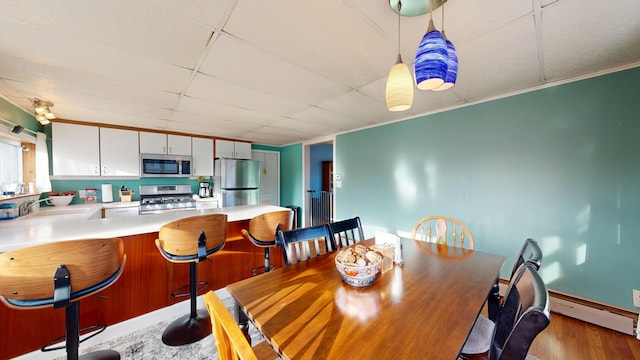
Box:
[0,0,214,69]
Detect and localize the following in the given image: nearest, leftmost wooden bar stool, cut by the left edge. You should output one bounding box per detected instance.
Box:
[0,238,127,360]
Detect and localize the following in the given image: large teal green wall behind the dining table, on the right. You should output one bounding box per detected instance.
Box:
[334,68,640,310]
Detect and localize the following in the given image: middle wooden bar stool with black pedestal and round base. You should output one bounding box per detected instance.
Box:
[156,214,227,346]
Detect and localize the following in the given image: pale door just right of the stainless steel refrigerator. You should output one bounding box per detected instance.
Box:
[251,150,280,206]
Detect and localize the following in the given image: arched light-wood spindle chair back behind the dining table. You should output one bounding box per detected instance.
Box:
[411,216,474,250]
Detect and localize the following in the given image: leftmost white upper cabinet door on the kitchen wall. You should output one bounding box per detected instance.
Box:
[51,122,100,176]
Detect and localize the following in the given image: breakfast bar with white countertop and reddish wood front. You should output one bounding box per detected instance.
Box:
[0,204,286,359]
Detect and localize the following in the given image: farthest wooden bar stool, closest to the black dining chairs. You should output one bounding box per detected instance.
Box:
[241,210,293,275]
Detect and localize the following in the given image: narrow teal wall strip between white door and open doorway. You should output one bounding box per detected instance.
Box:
[280,144,302,207]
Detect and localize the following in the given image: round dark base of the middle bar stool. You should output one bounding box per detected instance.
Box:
[162,309,211,346]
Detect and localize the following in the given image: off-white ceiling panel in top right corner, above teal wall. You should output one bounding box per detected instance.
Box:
[542,0,640,80]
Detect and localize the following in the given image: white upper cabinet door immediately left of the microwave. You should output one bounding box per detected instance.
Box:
[100,128,140,176]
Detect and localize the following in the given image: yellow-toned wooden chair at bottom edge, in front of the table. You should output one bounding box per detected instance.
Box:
[204,291,278,360]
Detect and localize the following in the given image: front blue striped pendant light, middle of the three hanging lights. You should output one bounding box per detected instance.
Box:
[414,3,447,90]
